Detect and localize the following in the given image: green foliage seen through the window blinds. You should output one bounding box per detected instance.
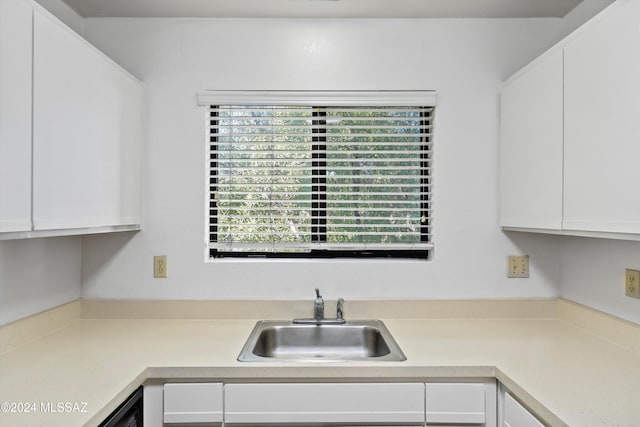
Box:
[212,106,430,251]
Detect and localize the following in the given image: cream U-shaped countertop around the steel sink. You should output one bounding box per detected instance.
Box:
[0,300,640,427]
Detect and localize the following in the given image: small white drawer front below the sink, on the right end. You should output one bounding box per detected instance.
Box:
[426,383,486,425]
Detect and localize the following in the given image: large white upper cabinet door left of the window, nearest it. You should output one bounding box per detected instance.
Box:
[33,10,142,230]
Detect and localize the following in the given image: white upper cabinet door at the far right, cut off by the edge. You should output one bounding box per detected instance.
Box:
[564,1,640,233]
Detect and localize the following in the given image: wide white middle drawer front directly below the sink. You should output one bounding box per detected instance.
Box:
[224,383,424,424]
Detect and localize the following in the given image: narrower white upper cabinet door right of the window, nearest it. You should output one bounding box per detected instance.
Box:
[500,49,563,230]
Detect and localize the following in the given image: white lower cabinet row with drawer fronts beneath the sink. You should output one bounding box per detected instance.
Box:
[144,380,500,427]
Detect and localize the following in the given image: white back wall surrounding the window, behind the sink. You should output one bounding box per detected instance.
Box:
[82,19,561,299]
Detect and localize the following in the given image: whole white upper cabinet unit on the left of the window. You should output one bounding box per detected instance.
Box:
[0,0,143,239]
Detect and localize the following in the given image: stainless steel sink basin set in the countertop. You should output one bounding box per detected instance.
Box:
[238,320,407,362]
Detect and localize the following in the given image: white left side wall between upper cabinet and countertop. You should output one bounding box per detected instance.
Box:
[0,237,81,325]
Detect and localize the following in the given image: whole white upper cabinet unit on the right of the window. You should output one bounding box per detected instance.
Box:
[500,0,640,240]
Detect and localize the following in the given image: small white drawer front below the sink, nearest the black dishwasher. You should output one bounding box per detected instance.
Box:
[164,383,222,424]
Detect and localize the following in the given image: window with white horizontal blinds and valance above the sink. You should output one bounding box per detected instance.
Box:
[199,92,434,258]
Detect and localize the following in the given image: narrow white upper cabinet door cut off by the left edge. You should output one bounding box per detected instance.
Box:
[0,1,32,233]
